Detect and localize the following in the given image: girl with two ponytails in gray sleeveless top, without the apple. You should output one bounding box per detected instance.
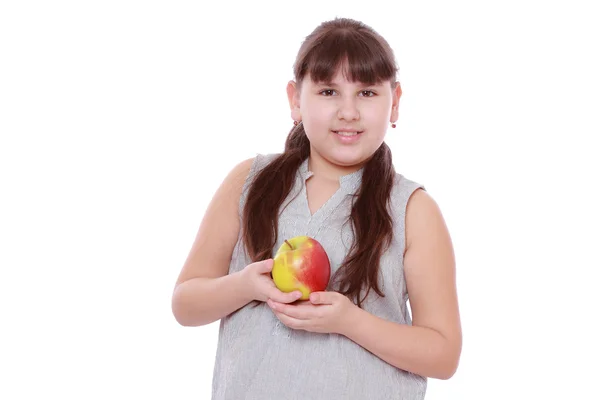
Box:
[173,19,462,400]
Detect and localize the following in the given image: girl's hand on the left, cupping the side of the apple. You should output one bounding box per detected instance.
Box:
[241,258,302,303]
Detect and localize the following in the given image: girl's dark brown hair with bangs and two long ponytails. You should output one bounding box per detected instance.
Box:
[242,18,397,307]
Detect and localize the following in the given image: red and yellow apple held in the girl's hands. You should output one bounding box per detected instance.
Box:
[271,236,331,300]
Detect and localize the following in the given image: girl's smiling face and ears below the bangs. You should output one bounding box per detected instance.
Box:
[288,70,401,169]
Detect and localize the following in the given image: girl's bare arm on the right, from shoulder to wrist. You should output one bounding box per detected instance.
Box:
[342,190,462,379]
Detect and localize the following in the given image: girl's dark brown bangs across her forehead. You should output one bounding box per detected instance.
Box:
[296,29,397,85]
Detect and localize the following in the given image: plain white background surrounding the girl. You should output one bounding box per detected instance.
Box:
[0,0,600,400]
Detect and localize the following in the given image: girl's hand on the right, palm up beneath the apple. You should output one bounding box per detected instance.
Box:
[267,292,356,334]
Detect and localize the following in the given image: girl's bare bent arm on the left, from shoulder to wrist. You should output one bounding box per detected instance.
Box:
[172,159,253,326]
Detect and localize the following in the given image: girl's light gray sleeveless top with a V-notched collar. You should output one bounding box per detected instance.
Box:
[212,154,427,400]
